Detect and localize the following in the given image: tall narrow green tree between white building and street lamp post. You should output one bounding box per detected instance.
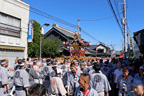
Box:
[28,20,41,57]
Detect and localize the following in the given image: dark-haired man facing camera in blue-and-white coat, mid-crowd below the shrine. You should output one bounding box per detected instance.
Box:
[66,63,81,96]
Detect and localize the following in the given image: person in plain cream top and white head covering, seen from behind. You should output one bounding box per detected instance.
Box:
[51,68,67,96]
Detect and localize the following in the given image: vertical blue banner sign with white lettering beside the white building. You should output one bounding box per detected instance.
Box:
[28,20,34,42]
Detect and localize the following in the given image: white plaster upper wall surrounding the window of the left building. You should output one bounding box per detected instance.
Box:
[0,0,29,58]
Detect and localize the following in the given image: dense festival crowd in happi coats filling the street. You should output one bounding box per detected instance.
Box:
[0,57,144,96]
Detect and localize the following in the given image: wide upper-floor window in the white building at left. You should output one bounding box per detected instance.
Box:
[0,12,21,38]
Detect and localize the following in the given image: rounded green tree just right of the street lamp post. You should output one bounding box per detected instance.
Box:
[42,37,62,57]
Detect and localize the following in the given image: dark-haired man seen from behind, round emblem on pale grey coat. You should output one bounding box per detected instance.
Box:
[90,63,111,96]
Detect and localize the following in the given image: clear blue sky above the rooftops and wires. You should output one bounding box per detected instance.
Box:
[23,0,144,50]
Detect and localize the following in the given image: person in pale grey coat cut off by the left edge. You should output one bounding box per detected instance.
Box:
[0,59,8,96]
